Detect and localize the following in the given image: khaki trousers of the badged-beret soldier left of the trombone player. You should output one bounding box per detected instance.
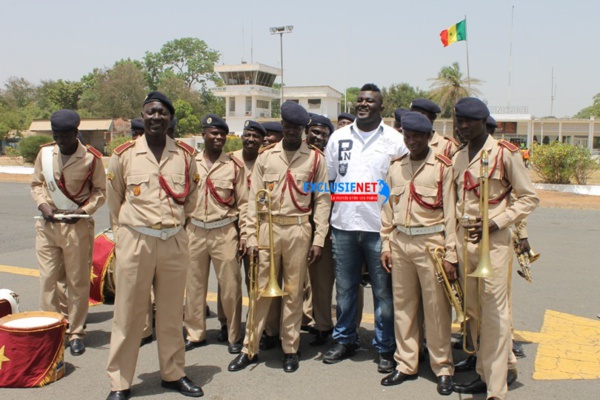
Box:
[185,223,242,343]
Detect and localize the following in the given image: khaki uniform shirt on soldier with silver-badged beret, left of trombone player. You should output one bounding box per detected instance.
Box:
[192,151,248,239]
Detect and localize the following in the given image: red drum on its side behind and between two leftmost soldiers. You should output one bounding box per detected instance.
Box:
[89,229,115,305]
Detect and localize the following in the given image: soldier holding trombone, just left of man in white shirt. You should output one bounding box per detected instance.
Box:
[228,101,331,372]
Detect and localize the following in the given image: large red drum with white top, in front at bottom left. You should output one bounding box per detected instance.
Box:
[0,311,67,388]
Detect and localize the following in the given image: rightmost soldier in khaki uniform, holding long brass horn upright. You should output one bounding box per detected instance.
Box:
[453,97,539,400]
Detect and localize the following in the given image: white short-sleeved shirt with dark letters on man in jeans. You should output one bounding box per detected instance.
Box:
[325,120,408,232]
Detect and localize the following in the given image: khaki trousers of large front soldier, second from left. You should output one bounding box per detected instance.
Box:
[107,225,189,390]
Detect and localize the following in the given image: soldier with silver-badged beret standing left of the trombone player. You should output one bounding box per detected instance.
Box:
[185,114,248,354]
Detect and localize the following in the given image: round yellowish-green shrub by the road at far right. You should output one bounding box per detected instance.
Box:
[530,142,600,185]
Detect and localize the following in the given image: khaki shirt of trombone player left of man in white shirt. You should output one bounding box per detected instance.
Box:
[246,142,331,247]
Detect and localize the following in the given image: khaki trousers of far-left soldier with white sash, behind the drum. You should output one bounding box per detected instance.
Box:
[35,218,94,340]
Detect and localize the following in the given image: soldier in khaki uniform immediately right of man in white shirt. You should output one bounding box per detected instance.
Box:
[381,111,457,395]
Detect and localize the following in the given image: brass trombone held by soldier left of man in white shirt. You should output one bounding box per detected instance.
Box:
[246,189,287,358]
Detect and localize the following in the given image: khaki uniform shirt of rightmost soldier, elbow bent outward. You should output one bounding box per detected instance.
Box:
[453,136,539,229]
